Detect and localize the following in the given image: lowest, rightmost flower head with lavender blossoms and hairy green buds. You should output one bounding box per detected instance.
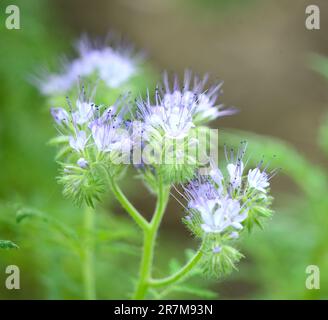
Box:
[177,142,273,277]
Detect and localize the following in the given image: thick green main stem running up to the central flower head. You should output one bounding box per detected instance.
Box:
[134,180,169,300]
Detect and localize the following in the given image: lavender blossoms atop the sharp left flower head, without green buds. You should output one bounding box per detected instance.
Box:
[51,88,131,160]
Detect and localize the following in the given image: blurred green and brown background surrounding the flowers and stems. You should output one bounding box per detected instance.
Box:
[0,0,328,299]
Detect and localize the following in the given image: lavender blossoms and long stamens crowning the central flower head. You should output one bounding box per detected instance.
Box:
[137,71,236,144]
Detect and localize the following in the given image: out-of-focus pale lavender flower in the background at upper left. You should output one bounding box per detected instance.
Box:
[35,37,141,95]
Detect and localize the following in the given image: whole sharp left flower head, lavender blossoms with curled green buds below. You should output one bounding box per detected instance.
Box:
[51,87,132,205]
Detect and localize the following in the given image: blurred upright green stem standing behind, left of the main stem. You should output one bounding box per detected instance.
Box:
[82,207,96,300]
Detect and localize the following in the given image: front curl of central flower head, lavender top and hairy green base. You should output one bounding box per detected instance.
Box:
[137,88,199,183]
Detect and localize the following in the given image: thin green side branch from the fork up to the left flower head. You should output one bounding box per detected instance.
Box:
[108,177,149,230]
